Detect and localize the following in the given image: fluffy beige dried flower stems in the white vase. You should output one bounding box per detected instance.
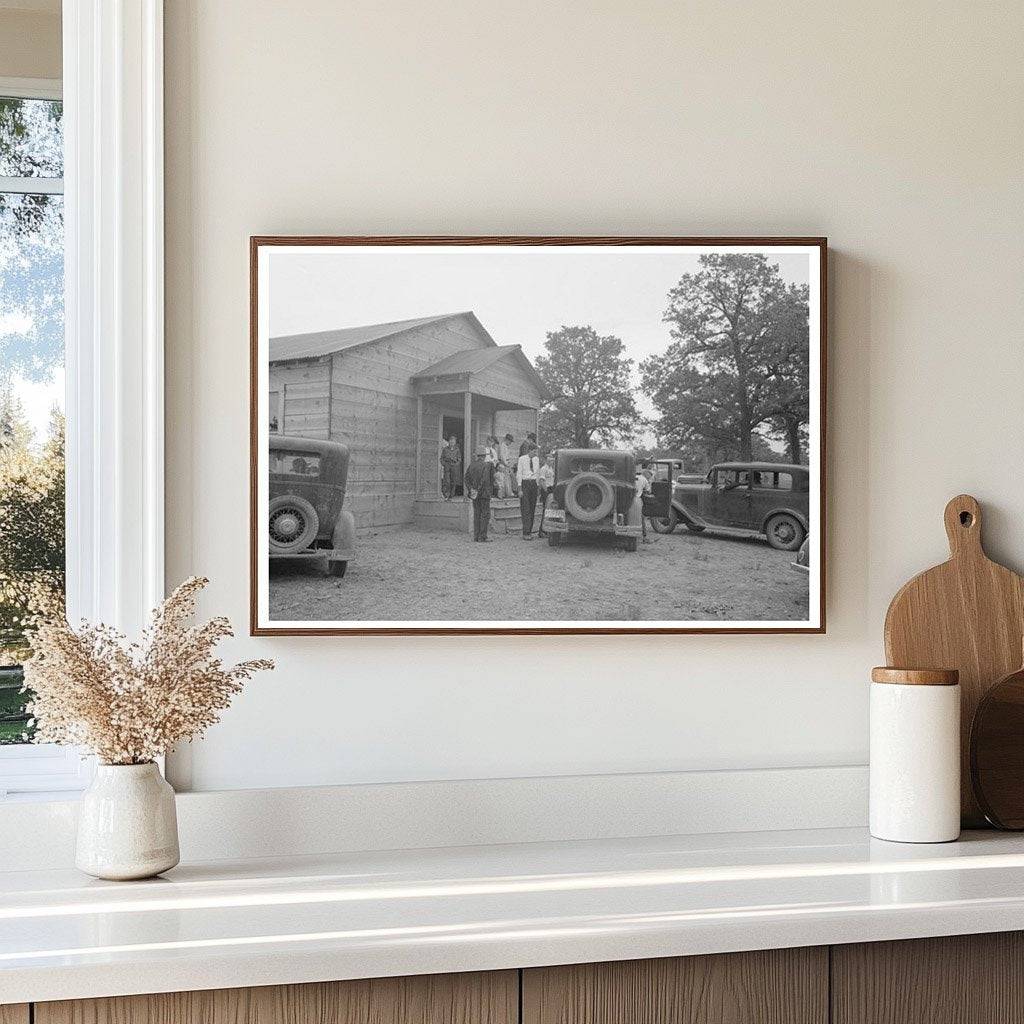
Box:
[25,577,273,765]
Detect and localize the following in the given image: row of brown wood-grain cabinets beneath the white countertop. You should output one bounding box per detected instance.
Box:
[16,933,1024,1024]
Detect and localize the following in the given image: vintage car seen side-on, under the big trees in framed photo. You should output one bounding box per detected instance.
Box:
[651,462,810,551]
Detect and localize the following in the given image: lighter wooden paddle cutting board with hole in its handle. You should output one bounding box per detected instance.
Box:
[886,495,1024,827]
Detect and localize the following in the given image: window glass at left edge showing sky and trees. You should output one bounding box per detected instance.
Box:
[0,85,65,745]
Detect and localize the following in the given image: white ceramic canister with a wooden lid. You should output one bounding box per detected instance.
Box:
[870,668,961,843]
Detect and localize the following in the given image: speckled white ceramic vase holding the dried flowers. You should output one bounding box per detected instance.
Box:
[75,762,179,881]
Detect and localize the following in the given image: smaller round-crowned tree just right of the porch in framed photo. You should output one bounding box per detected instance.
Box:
[535,326,641,447]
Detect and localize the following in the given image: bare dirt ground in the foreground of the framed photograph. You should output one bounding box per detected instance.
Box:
[270,526,809,622]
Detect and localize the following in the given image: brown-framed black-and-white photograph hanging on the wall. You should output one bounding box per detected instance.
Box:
[250,237,826,635]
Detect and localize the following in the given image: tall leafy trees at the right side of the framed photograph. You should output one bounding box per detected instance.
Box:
[640,253,809,462]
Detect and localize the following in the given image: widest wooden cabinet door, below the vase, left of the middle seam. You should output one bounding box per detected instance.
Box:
[36,971,518,1024]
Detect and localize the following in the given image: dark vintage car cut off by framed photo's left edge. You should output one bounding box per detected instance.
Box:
[268,434,355,577]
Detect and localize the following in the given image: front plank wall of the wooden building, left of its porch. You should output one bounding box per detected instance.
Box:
[331,319,484,530]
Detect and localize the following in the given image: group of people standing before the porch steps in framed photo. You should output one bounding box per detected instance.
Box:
[463,433,555,542]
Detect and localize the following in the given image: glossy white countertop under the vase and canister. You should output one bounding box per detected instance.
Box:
[6,828,1024,1002]
